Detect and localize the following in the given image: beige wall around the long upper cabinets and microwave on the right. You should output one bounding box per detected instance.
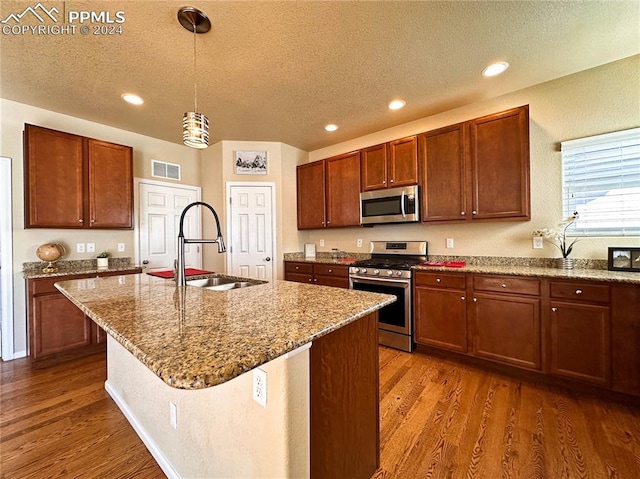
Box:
[304,55,640,259]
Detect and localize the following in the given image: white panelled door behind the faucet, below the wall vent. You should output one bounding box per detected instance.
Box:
[138,181,202,271]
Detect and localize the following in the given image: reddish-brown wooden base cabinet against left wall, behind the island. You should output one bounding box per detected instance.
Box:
[27,269,141,363]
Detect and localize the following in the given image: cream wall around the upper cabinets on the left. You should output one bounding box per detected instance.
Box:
[0,99,200,356]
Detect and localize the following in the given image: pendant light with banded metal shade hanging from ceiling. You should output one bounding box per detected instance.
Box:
[178,7,211,148]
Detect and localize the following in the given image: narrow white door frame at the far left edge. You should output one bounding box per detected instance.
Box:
[0,156,15,361]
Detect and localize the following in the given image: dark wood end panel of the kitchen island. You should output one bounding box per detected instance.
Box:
[309,312,380,479]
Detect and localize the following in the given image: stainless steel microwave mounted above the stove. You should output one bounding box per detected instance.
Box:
[360,185,420,225]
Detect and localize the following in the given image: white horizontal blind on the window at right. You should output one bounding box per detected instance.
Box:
[562,128,640,236]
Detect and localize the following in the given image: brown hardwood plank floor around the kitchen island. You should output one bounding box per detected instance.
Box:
[0,347,640,479]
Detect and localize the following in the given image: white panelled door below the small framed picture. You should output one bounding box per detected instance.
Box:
[227,184,275,280]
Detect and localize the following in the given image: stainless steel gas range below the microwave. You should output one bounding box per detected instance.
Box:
[349,241,427,352]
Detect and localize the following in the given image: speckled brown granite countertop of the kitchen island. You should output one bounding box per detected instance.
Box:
[56,274,395,389]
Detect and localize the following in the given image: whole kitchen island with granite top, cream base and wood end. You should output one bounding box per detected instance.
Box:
[57,274,395,478]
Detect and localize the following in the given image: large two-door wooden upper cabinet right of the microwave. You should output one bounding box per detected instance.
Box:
[419,105,531,223]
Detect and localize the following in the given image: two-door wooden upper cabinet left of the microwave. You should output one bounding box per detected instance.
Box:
[296,151,360,229]
